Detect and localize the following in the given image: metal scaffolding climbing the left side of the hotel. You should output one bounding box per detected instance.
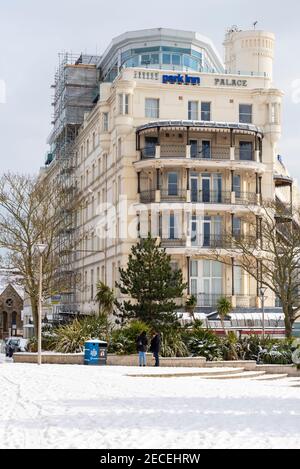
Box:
[46,53,99,314]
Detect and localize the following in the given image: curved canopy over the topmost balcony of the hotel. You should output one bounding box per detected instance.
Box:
[136,120,263,138]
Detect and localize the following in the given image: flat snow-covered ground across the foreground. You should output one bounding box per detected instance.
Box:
[0,356,300,449]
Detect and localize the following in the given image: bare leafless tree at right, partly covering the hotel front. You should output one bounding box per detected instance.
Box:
[212,199,300,337]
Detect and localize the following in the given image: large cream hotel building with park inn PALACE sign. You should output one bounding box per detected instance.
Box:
[42,28,295,322]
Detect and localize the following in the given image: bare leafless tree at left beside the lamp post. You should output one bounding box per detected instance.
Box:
[0,173,70,333]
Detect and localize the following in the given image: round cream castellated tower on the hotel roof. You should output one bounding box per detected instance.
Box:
[224,26,275,79]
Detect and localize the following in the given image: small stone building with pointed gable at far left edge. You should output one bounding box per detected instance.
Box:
[0,284,23,340]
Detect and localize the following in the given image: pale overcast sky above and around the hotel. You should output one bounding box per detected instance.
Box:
[0,0,300,180]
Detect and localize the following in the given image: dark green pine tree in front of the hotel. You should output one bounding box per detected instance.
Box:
[116,235,186,330]
